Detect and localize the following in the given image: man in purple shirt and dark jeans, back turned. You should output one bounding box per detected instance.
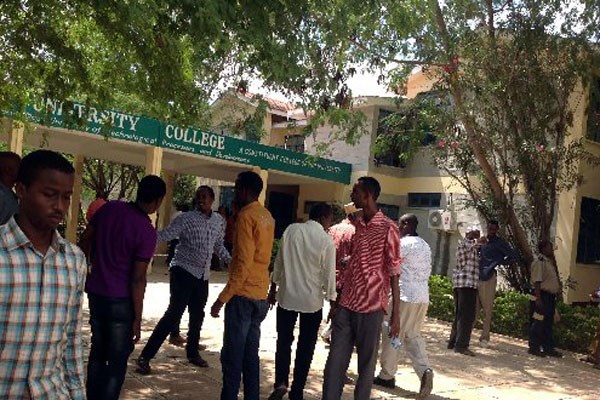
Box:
[81,175,166,400]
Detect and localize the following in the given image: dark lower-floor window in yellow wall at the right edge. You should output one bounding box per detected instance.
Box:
[577,197,600,264]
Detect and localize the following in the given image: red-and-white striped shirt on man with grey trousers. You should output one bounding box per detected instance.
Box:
[340,211,400,313]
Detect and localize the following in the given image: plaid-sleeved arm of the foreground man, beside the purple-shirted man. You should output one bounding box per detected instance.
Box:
[63,256,87,400]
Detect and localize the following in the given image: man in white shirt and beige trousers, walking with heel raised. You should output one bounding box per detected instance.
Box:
[373,214,433,400]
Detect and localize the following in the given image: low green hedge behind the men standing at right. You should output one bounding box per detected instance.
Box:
[427,275,600,353]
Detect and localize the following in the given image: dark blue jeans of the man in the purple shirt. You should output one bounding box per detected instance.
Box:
[86,293,134,400]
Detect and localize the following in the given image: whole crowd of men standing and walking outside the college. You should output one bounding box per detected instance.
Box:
[0,150,600,400]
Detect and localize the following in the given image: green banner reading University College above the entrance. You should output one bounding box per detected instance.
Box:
[19,99,352,184]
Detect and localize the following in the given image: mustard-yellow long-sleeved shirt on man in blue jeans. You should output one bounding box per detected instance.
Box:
[219,201,275,303]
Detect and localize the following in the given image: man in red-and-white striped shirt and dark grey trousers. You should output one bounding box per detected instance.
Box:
[323,177,400,400]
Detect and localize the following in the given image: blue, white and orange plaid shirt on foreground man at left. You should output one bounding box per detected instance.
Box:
[0,218,87,400]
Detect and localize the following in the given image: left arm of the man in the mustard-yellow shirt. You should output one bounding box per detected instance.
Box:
[210,214,256,318]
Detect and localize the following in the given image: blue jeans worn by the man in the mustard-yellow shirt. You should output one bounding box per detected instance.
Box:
[221,296,269,400]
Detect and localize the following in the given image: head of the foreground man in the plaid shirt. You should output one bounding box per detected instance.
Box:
[15,150,75,231]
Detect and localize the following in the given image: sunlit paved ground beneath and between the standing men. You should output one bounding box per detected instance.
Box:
[86,267,600,400]
